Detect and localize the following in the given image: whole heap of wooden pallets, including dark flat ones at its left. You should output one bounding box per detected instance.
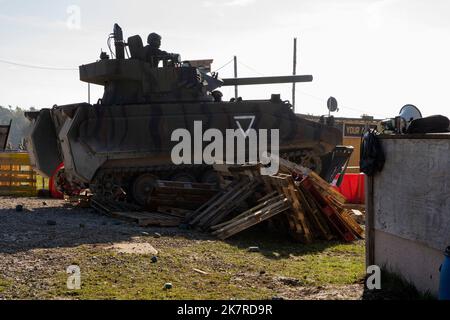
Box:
[86,159,364,243]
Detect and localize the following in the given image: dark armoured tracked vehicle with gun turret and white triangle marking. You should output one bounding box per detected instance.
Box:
[27,24,351,204]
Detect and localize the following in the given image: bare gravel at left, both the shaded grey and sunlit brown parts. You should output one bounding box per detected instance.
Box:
[0,197,193,299]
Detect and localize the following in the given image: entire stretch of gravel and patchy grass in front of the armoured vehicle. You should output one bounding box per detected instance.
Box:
[0,197,364,300]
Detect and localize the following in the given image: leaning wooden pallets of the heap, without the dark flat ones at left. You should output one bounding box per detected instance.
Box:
[187,159,364,243]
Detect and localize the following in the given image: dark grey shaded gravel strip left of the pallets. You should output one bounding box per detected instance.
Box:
[0,198,186,254]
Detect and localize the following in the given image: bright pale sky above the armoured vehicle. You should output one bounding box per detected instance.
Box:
[0,0,450,118]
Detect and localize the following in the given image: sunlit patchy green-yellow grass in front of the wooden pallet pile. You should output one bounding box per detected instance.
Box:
[41,232,365,300]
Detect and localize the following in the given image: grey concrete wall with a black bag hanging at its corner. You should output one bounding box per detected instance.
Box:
[367,135,450,295]
